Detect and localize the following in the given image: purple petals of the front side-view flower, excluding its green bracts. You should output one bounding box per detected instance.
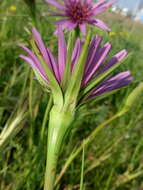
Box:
[19,28,133,102]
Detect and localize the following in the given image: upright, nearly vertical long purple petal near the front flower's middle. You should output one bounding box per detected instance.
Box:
[58,27,67,80]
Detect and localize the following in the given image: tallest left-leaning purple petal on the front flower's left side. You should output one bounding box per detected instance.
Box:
[32,28,52,70]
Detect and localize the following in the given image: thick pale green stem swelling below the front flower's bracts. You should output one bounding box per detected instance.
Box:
[44,106,74,190]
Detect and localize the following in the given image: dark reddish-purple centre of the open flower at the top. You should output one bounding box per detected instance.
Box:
[68,2,89,24]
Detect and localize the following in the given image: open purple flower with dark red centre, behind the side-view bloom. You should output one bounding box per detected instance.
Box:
[45,0,116,34]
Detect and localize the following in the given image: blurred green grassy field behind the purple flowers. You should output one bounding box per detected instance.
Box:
[0,0,143,190]
